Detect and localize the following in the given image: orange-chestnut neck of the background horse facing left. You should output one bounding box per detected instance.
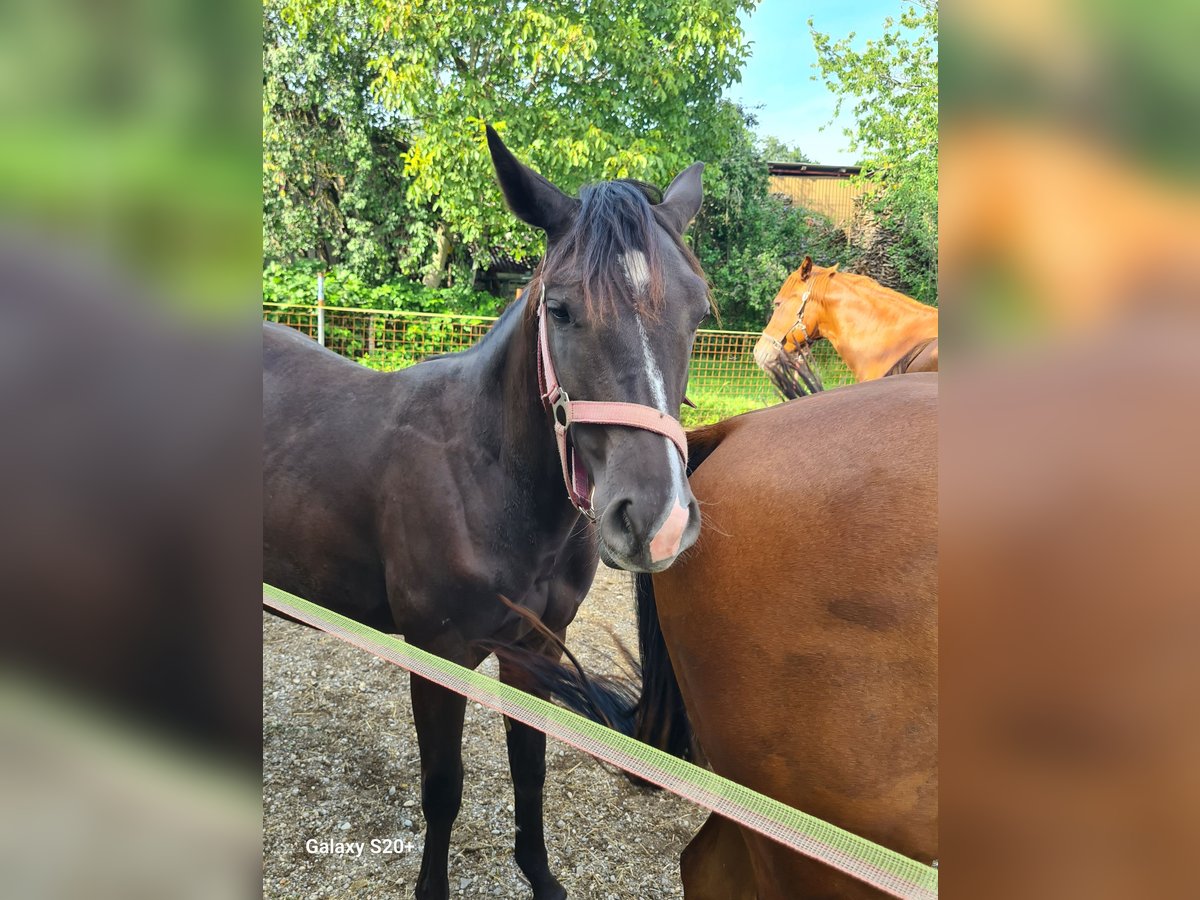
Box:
[816,287,937,382]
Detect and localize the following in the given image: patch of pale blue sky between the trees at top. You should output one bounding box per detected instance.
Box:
[726,0,906,164]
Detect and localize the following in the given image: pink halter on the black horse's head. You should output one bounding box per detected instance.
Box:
[538,283,688,520]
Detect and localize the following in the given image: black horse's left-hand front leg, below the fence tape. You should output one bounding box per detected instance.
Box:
[412,676,467,900]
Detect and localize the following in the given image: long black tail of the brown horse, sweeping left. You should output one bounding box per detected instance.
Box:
[486,575,695,760]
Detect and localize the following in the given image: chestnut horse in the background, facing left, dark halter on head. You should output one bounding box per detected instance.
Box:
[754,257,937,396]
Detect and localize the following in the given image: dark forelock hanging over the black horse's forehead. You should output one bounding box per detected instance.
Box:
[533,179,703,317]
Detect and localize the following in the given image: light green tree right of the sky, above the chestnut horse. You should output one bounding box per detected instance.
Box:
[809,0,937,302]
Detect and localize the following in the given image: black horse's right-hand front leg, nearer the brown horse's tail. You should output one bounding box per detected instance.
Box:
[500,637,566,900]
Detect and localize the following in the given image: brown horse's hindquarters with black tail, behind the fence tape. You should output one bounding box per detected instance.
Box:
[506,374,937,900]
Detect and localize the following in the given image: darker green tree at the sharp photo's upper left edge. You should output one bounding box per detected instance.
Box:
[263,2,412,282]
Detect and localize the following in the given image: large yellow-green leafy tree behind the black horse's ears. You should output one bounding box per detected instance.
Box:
[268,0,757,284]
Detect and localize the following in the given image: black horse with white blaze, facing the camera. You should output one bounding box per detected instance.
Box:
[263,128,709,900]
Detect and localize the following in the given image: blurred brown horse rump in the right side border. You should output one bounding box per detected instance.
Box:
[940,314,1200,899]
